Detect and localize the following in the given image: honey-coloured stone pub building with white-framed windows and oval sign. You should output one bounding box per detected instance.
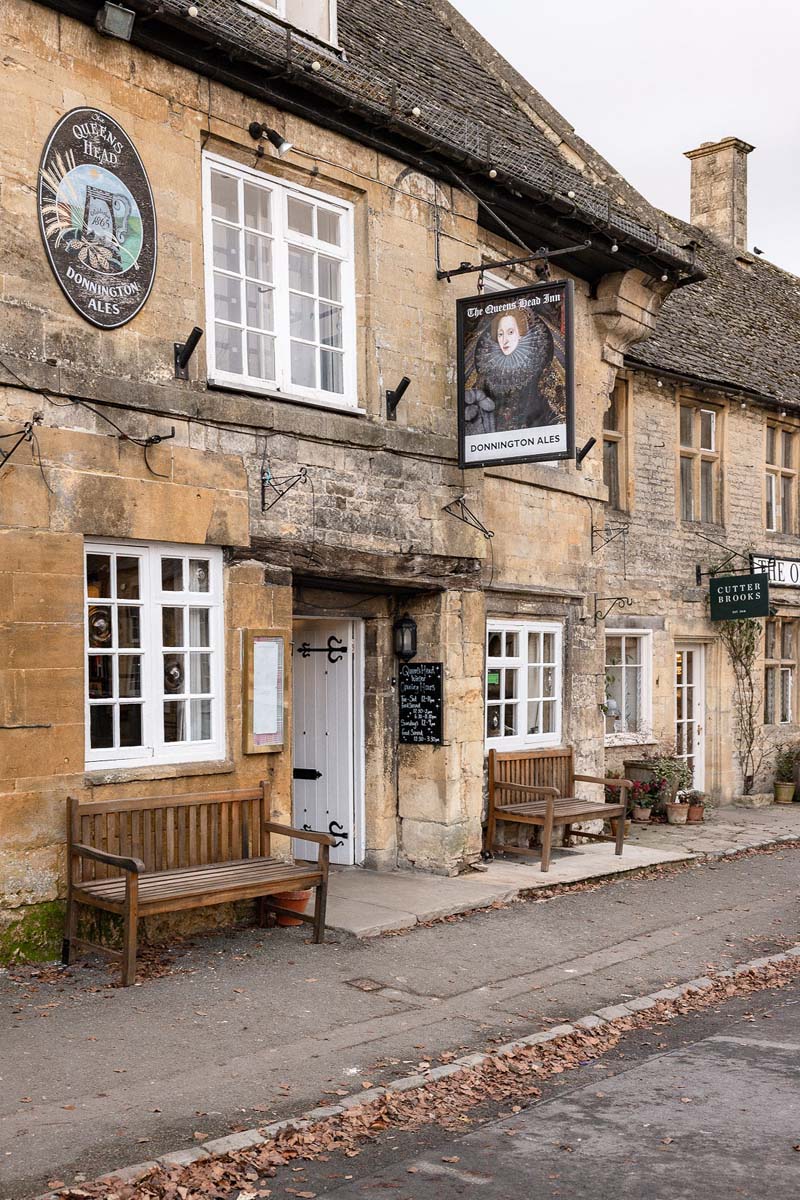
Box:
[0,0,700,956]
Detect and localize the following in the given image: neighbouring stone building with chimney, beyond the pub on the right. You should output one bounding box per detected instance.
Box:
[602,138,800,802]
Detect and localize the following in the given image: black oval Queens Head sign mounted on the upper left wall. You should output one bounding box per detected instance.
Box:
[38,108,157,329]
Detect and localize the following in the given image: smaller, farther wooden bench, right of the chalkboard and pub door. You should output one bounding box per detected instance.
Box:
[486,746,633,871]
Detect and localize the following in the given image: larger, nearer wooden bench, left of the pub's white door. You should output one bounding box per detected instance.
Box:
[62,784,335,986]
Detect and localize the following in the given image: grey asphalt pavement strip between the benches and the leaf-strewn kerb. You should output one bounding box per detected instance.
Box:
[0,848,800,1200]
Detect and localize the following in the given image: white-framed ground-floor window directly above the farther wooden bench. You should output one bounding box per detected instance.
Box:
[486,622,563,750]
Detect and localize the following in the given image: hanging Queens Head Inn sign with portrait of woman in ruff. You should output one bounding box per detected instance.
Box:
[457,281,575,467]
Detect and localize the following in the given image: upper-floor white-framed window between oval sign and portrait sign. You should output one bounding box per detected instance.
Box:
[203,155,356,408]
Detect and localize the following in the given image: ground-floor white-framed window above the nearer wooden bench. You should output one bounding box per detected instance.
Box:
[85,541,224,767]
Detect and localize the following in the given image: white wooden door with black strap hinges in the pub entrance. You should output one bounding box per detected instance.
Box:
[291,620,361,865]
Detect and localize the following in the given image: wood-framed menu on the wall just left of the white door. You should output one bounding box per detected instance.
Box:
[242,629,285,754]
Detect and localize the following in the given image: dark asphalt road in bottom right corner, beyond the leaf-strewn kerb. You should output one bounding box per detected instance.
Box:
[302,983,800,1200]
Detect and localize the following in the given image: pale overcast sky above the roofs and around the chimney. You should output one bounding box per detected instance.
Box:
[451,0,800,275]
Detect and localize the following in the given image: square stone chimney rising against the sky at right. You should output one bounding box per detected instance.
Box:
[686,138,754,250]
